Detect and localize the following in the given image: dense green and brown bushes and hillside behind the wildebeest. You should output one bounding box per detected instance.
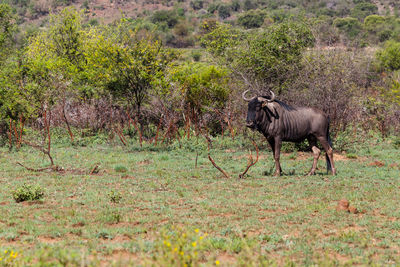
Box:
[0,0,400,149]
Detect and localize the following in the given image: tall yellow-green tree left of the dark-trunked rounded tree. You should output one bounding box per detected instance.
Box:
[25,8,86,141]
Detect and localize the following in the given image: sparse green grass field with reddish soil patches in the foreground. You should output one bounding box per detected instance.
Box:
[0,133,400,266]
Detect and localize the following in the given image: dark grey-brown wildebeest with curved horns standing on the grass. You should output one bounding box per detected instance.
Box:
[242,90,336,176]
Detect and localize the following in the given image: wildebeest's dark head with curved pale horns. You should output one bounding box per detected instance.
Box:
[242,90,275,129]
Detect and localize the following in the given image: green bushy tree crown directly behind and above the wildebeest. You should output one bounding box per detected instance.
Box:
[203,22,314,93]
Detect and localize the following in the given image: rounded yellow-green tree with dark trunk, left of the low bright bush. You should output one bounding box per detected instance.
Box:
[86,19,175,124]
